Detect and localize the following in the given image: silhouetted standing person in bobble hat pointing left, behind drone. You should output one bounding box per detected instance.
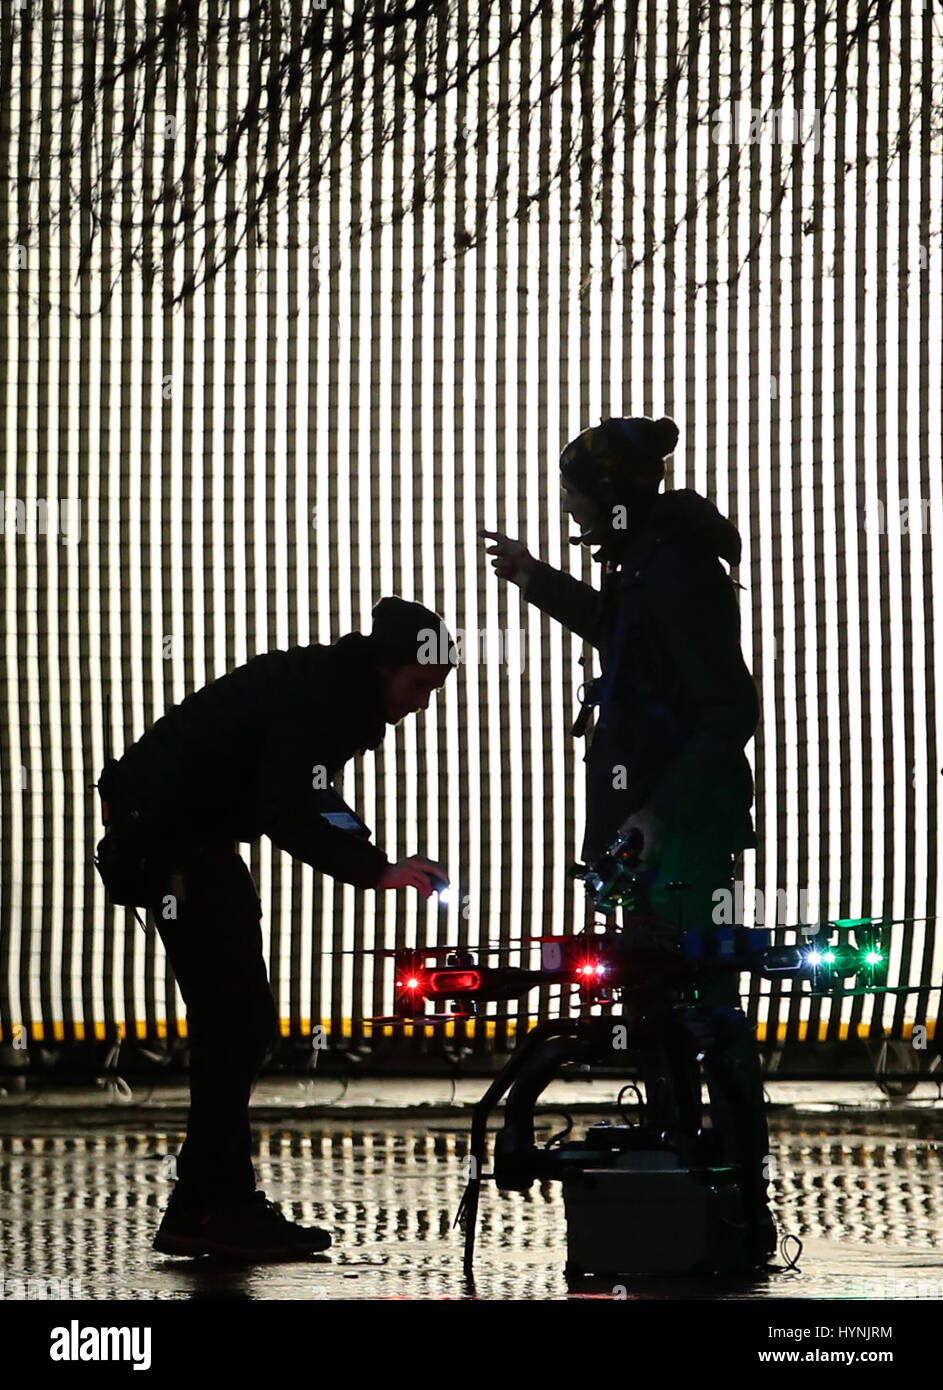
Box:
[483,417,776,1259]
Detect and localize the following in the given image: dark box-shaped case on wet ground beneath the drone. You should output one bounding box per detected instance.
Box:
[563,1152,748,1276]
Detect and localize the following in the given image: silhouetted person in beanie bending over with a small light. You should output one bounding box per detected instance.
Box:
[97,598,456,1259]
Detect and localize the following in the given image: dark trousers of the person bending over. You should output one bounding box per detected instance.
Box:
[142,845,278,1207]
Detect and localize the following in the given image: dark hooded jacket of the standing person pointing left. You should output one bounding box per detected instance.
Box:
[523,489,759,860]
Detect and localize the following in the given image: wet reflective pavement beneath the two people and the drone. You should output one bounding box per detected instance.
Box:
[0,1079,943,1301]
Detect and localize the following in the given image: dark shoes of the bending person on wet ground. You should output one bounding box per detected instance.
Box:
[154,1191,331,1261]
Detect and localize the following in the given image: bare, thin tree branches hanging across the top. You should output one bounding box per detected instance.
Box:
[0,0,939,314]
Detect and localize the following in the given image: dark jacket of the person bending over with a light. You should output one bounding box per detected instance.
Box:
[96,632,389,888]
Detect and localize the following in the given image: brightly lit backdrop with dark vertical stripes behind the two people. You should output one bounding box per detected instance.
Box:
[0,0,943,1041]
